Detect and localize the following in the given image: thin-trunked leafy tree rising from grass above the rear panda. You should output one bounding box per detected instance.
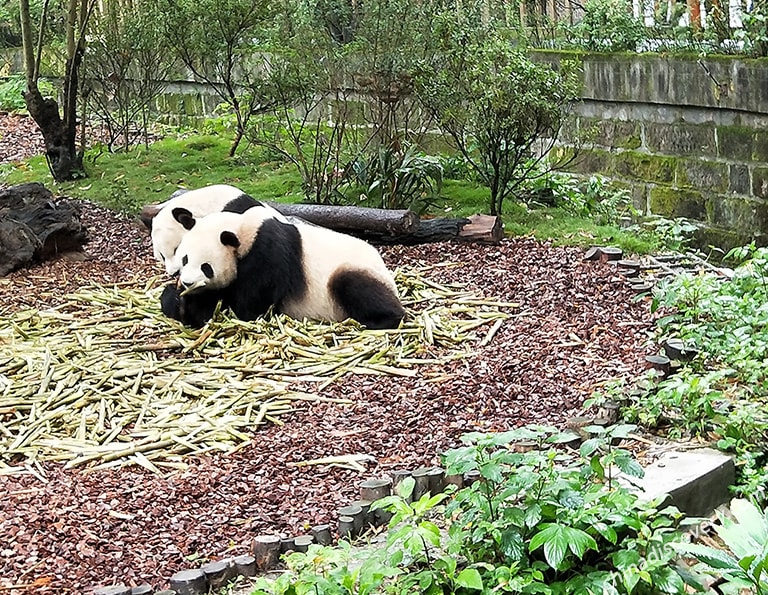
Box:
[164,0,273,157]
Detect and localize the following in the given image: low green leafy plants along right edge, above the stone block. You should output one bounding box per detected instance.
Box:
[600,245,768,504]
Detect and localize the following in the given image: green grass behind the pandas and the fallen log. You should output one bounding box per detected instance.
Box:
[0,128,661,254]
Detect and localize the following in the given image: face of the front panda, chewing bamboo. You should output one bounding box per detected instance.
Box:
[176,214,240,293]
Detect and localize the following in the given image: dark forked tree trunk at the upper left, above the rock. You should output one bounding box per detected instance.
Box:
[19,0,94,182]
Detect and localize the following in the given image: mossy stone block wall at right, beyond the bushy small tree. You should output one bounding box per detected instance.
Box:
[535,52,768,247]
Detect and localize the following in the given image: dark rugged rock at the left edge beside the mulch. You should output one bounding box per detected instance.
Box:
[0,182,88,277]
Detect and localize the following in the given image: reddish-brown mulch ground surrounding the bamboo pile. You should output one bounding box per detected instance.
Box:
[0,114,651,595]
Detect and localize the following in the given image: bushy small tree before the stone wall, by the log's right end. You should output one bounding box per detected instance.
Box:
[416,16,578,215]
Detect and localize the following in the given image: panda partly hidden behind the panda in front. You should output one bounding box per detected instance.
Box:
[142,184,282,275]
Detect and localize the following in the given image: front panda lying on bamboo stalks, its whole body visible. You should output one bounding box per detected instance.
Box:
[161,206,405,329]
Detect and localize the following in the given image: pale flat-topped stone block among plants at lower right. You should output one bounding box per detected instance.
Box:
[642,448,736,516]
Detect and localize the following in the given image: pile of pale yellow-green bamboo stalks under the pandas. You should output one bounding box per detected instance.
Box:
[0,271,515,473]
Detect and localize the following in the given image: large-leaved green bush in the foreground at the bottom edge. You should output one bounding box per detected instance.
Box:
[248,426,698,595]
